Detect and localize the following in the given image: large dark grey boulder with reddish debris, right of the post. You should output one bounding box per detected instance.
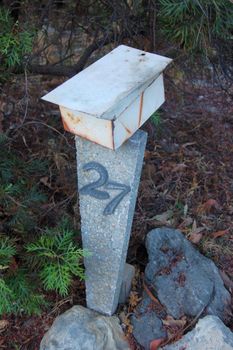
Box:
[145,228,230,319]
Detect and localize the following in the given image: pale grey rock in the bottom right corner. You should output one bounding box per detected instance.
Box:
[163,316,233,350]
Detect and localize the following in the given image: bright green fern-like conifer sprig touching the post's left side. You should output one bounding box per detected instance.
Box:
[27,221,87,296]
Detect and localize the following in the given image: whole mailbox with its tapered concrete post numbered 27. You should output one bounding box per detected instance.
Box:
[43,45,171,315]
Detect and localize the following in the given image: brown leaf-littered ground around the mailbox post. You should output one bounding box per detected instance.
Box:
[0,59,233,350]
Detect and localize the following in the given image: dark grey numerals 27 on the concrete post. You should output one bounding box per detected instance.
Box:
[79,162,131,215]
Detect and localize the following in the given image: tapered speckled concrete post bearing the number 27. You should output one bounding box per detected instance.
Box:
[76,130,147,315]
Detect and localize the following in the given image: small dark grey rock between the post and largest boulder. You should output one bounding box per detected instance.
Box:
[131,293,167,350]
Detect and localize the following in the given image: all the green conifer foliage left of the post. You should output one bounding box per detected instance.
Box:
[0,135,87,315]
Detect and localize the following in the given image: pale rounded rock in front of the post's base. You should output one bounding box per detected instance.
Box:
[40,306,129,350]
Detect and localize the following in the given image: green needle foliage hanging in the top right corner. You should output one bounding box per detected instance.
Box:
[158,0,233,53]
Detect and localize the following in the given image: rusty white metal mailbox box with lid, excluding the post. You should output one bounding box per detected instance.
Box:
[42,45,171,150]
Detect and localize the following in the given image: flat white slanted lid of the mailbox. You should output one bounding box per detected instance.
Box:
[42,45,171,120]
